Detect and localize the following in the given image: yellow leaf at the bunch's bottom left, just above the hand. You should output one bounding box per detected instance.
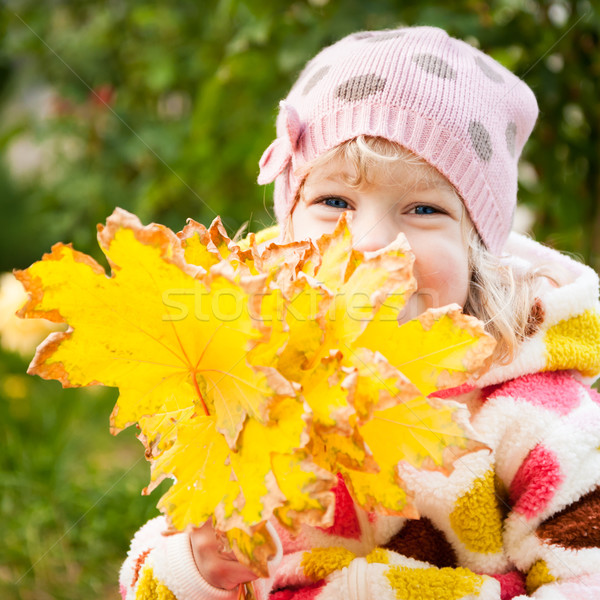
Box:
[152,398,334,535]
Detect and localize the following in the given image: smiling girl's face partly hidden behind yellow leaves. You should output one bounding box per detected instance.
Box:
[291,159,471,321]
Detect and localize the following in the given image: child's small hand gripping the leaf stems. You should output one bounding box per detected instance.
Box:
[190,520,257,590]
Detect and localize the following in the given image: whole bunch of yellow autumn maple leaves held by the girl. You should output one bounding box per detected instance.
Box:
[17,209,494,574]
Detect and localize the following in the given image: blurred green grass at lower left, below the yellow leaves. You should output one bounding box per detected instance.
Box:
[0,346,169,600]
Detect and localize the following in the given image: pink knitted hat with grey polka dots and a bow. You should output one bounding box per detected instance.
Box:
[258,27,538,253]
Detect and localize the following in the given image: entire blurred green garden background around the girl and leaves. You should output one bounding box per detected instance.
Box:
[0,0,600,600]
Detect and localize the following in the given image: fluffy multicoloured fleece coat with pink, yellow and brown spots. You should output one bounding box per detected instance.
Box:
[121,234,600,600]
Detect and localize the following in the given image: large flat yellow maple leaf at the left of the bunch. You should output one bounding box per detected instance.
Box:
[20,209,293,445]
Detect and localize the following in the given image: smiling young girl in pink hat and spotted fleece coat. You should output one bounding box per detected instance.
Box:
[121,27,600,600]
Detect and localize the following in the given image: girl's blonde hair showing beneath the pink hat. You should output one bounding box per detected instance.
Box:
[285,136,541,364]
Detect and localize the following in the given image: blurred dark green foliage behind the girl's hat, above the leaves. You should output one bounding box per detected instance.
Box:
[0,0,600,270]
